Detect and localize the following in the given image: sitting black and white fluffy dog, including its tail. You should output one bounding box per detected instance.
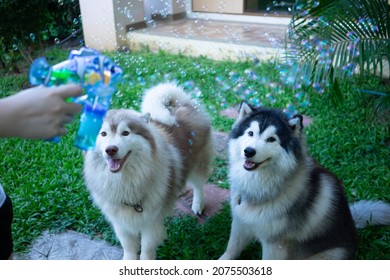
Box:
[221,102,390,259]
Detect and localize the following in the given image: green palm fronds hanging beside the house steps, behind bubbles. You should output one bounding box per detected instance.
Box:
[286,0,390,101]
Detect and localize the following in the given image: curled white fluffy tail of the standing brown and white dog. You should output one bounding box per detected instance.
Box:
[141,83,192,125]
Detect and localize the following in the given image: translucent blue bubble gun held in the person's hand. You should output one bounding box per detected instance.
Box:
[29,47,122,150]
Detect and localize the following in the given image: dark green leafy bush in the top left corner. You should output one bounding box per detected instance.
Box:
[0,0,81,72]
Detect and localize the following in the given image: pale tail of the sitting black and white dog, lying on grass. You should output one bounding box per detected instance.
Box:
[350,200,390,228]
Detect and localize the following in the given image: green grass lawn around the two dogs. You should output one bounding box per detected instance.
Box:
[0,47,390,259]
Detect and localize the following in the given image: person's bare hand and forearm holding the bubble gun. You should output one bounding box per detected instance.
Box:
[0,85,82,139]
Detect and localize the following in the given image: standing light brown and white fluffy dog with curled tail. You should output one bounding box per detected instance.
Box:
[84,83,213,259]
